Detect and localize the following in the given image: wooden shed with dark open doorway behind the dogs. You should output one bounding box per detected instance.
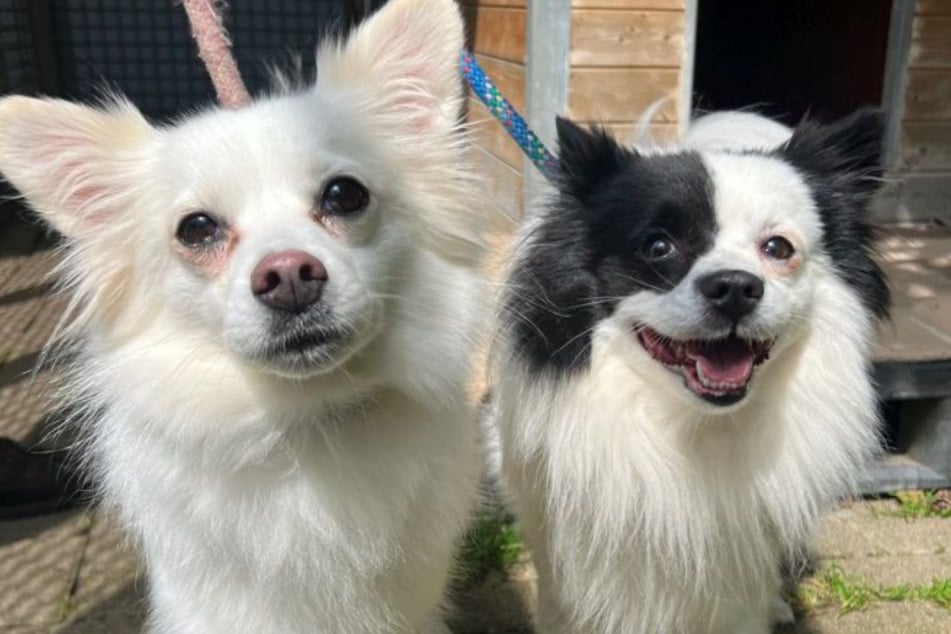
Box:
[461,0,951,223]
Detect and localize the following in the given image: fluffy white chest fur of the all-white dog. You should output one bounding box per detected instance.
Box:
[83,328,478,632]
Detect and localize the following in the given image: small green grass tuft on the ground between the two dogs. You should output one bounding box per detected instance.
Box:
[461,514,522,582]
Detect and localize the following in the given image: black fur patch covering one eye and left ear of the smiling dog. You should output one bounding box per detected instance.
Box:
[503,119,716,372]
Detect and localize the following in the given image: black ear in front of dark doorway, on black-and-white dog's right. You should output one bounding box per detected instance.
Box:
[782,108,885,201]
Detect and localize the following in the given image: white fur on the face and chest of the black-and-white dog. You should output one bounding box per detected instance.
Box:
[494,113,878,634]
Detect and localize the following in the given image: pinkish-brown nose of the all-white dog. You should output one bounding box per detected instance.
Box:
[251,250,327,313]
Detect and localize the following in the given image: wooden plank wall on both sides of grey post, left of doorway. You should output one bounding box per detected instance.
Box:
[460,0,685,225]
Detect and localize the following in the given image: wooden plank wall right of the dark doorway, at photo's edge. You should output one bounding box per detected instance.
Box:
[895,0,951,222]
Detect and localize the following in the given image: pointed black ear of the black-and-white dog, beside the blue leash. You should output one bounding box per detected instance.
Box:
[555,117,631,199]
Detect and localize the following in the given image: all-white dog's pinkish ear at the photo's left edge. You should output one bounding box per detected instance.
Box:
[0,96,154,237]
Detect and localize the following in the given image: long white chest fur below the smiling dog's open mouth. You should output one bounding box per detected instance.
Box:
[499,276,877,633]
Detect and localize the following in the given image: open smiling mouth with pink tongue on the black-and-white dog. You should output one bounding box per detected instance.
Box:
[637,326,773,405]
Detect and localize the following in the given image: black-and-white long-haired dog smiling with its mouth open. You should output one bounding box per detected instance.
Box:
[493,111,889,634]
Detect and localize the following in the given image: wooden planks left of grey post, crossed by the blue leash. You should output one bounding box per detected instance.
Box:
[460,0,527,223]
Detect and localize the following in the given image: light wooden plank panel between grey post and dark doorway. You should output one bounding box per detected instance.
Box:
[568,0,685,139]
